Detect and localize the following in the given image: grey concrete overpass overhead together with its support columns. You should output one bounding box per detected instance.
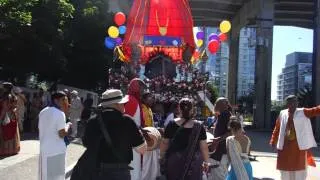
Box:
[110,0,320,139]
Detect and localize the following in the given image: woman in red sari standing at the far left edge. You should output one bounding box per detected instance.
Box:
[0,83,20,156]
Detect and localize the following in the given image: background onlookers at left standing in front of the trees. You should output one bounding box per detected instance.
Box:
[0,82,93,156]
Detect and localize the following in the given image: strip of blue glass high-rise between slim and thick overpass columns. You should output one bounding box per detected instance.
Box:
[237,28,256,98]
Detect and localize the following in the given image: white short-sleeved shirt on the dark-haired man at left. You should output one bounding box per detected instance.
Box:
[38,107,67,155]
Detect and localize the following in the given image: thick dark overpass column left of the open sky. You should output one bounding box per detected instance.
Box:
[254,0,274,128]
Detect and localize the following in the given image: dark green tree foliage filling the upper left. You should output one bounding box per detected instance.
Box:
[0,0,112,89]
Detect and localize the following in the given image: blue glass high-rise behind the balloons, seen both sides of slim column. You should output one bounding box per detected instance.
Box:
[200,27,256,97]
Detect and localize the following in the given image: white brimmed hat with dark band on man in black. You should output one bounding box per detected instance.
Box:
[99,89,129,107]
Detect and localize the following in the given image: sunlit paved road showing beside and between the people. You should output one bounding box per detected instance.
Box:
[0,131,320,180]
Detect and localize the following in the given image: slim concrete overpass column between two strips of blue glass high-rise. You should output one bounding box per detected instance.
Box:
[227,29,240,105]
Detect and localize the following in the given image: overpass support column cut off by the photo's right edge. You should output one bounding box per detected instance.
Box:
[312,0,320,141]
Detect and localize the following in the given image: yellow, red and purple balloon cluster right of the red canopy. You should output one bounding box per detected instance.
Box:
[208,20,231,54]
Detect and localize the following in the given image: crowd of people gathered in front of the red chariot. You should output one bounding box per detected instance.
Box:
[0,78,320,180]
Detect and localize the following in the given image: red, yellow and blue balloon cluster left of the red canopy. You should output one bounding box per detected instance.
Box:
[104,12,127,49]
